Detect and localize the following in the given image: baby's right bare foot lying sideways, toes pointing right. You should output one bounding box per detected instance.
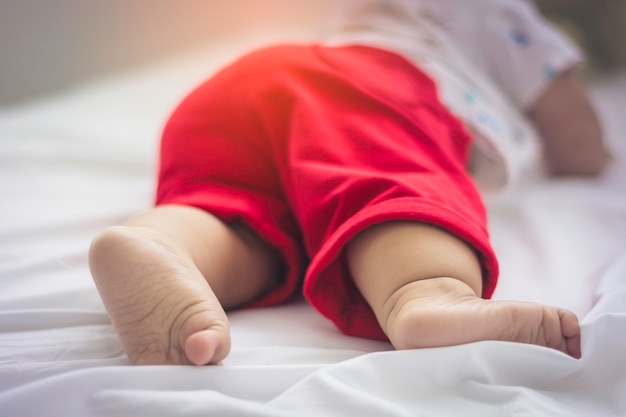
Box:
[386,278,581,358]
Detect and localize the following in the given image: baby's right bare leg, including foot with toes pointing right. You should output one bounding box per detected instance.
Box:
[347,222,580,358]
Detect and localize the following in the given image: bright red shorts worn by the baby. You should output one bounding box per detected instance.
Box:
[157,45,498,340]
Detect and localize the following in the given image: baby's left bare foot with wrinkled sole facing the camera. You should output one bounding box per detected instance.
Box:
[90,226,230,365]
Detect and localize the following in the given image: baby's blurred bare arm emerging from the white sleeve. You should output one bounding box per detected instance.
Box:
[529,70,610,175]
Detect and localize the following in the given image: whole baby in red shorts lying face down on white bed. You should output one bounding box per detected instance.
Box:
[90,0,608,365]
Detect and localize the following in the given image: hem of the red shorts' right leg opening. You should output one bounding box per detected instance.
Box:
[304,197,498,341]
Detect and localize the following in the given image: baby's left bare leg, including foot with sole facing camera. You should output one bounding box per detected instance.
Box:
[89,206,281,365]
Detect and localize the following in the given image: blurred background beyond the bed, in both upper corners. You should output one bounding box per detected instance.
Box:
[0,0,626,106]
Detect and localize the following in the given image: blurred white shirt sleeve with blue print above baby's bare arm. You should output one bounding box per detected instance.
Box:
[420,0,584,109]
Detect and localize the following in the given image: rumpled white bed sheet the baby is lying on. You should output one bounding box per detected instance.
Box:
[0,38,626,417]
